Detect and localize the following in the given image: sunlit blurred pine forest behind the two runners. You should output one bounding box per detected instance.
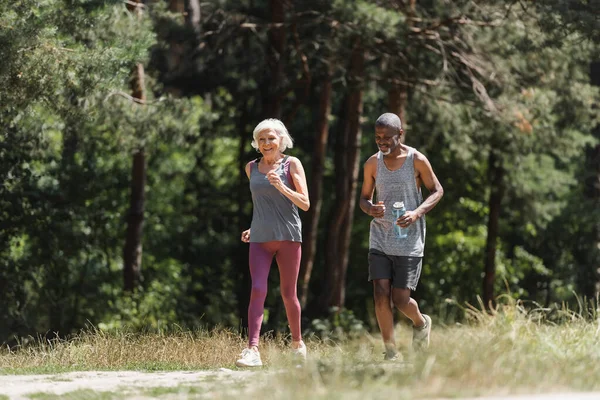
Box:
[0,0,600,343]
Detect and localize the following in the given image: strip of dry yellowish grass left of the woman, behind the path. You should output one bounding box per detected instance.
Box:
[0,330,244,374]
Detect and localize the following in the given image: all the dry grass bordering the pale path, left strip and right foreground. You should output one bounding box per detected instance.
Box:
[0,302,600,400]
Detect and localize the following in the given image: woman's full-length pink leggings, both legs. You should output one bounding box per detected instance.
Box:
[248,241,302,347]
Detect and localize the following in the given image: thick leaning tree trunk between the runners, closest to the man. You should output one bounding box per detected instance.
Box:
[319,38,365,310]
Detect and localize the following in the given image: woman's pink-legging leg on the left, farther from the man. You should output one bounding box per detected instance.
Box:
[248,242,275,348]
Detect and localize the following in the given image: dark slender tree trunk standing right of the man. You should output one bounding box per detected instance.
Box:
[483,150,504,308]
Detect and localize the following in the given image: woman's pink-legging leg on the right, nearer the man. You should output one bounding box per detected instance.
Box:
[276,241,302,342]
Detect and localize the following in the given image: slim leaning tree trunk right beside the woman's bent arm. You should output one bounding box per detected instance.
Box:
[299,67,332,308]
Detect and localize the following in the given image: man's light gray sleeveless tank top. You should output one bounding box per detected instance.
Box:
[369,146,425,257]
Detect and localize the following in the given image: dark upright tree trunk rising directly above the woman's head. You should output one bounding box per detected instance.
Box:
[262,0,285,118]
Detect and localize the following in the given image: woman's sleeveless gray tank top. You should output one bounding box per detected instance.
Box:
[250,156,302,243]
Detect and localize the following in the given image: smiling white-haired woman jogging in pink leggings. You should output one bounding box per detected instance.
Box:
[236,119,310,367]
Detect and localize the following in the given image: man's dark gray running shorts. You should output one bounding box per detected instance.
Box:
[369,249,423,290]
